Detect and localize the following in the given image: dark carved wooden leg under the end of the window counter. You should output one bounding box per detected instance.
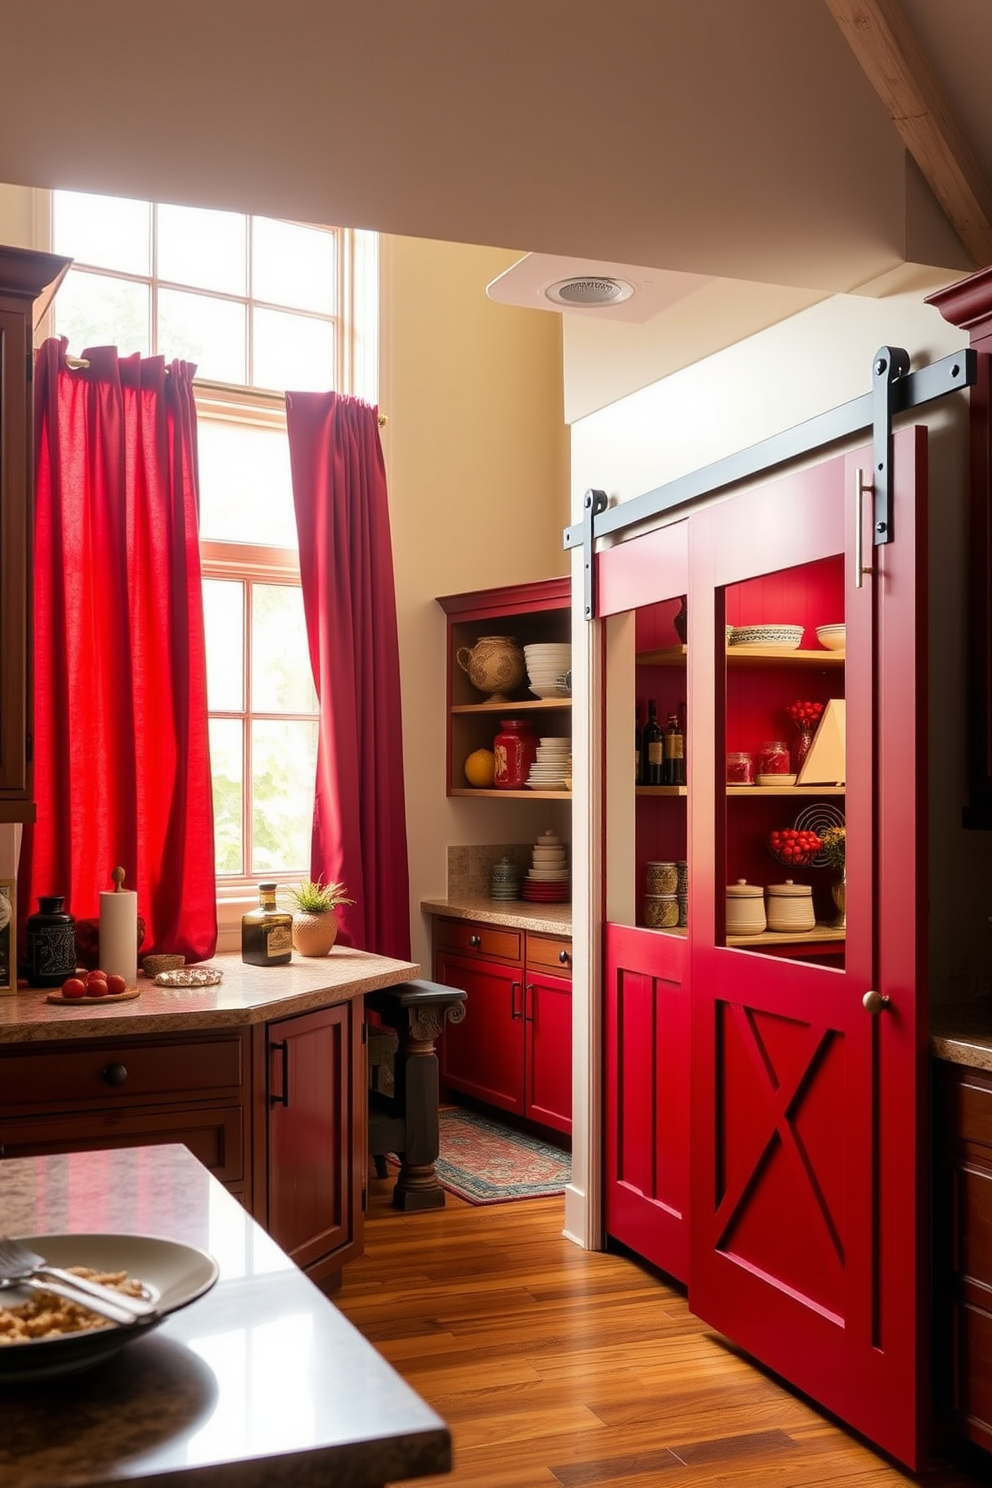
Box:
[366,981,466,1210]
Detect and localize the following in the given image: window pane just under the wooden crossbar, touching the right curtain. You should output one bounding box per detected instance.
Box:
[251,583,317,713]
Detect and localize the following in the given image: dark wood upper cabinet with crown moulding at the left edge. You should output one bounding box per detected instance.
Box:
[0,247,71,821]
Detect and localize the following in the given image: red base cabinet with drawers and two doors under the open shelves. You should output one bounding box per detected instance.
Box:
[434,920,571,1134]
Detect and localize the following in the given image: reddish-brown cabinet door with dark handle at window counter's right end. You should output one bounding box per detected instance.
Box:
[266,1003,364,1274]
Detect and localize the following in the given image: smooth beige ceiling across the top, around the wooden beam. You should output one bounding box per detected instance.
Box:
[0,0,992,337]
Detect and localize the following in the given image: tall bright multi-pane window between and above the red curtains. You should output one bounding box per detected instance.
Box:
[52,192,378,897]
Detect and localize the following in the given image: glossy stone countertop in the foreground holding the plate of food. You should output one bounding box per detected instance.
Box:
[0,1146,451,1488]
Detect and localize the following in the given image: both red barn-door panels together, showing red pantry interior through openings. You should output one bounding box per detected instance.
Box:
[596,430,927,1464]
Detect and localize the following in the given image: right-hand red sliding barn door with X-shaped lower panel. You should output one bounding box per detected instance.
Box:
[689,430,927,1466]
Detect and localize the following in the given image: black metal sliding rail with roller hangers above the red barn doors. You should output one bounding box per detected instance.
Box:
[562,347,979,620]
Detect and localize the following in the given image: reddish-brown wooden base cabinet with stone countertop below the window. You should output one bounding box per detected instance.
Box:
[0,946,419,1286]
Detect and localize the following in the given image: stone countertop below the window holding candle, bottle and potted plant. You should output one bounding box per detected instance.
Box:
[0,945,421,1045]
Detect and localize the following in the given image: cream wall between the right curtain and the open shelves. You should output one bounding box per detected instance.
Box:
[379,238,568,967]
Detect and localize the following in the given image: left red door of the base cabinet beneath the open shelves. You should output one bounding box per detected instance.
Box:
[434,951,524,1116]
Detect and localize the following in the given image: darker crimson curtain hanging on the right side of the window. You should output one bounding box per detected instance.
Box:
[286,393,410,960]
